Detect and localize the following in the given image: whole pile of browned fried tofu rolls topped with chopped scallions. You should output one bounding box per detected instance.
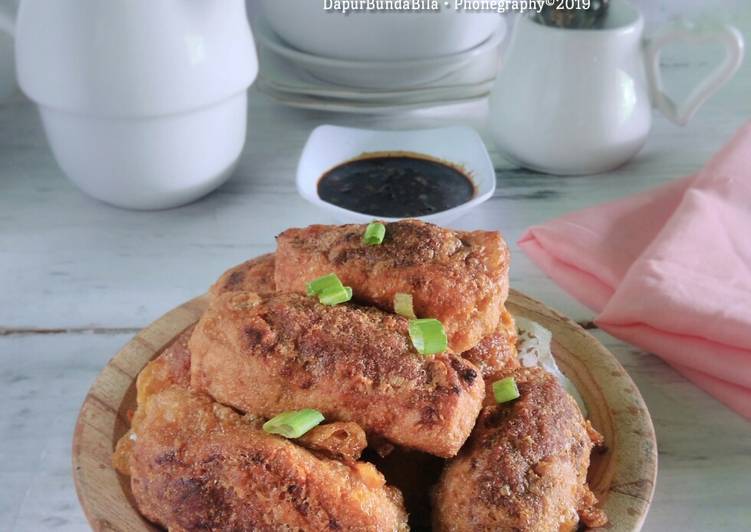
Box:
[113,220,606,532]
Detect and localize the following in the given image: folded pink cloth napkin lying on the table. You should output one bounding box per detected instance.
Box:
[519,124,751,419]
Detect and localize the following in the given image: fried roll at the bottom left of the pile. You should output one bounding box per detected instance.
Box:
[130,386,407,532]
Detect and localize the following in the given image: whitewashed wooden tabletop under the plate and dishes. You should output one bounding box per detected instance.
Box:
[0,2,751,531]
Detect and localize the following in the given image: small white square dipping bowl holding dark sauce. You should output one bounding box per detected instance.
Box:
[297,125,495,225]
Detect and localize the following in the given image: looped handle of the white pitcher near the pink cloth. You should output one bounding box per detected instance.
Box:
[644,20,744,126]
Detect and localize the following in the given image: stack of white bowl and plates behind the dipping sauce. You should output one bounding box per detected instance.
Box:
[253,0,506,113]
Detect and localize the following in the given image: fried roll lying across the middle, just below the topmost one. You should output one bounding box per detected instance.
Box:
[189,292,484,457]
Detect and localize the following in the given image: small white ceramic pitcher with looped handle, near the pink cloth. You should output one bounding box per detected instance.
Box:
[489,0,743,174]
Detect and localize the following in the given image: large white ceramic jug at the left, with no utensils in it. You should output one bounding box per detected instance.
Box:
[0,0,258,209]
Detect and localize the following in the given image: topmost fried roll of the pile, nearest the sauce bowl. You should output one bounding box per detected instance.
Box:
[275,220,509,353]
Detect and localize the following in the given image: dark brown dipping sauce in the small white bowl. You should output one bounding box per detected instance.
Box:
[318,155,475,218]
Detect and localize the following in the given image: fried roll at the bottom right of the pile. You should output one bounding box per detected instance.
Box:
[433,368,606,532]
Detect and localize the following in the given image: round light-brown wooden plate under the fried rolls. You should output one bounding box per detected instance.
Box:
[73,291,657,531]
